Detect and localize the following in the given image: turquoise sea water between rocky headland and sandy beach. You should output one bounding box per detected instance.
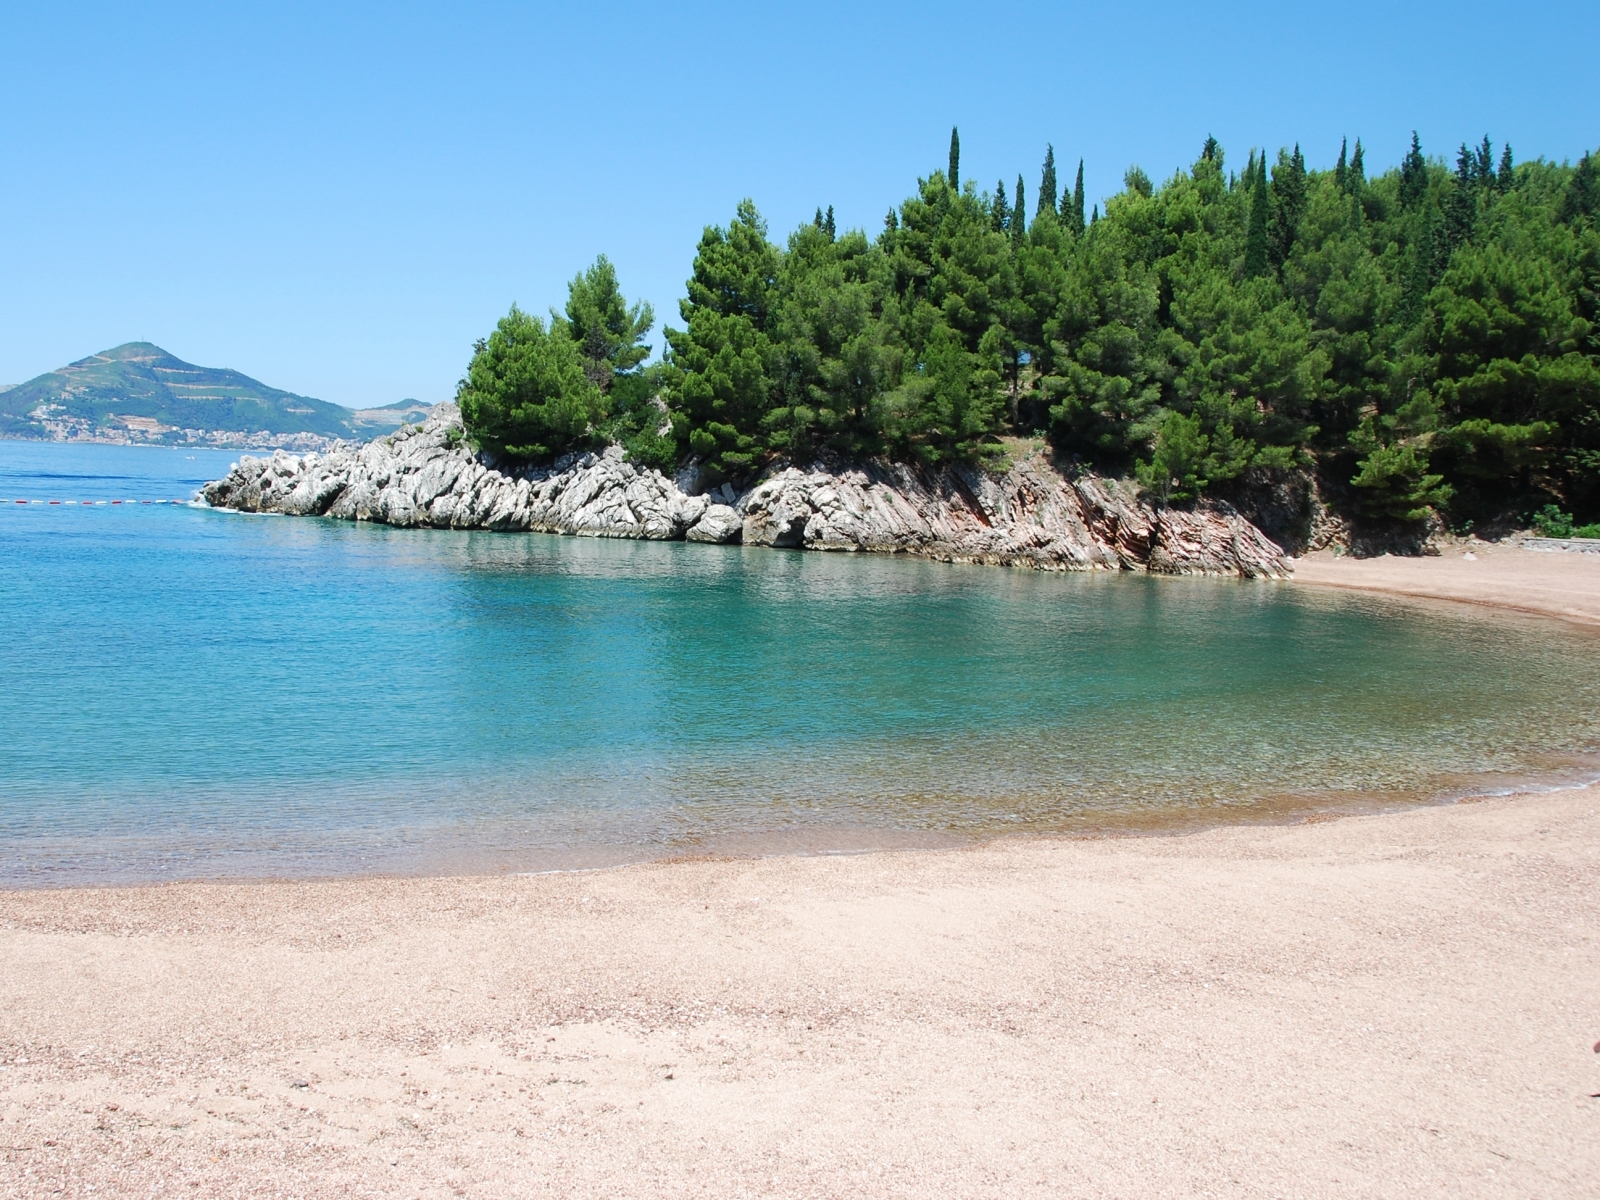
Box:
[9,442,1600,885]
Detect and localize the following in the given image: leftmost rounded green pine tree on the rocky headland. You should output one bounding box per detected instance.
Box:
[456,304,606,459]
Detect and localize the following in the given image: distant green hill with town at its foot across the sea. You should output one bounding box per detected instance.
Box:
[0,342,360,440]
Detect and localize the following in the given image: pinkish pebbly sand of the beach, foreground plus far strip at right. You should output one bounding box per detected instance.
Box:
[0,554,1600,1197]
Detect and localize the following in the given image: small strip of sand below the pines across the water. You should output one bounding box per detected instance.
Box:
[1294,542,1600,626]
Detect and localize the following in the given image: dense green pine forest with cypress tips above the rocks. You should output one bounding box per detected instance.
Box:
[459,131,1600,533]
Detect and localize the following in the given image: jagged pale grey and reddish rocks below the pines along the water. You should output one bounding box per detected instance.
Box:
[202,405,1291,579]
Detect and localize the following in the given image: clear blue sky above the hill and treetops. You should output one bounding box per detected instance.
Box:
[0,0,1600,406]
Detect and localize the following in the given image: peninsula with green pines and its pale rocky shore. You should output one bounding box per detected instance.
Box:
[208,131,1600,574]
